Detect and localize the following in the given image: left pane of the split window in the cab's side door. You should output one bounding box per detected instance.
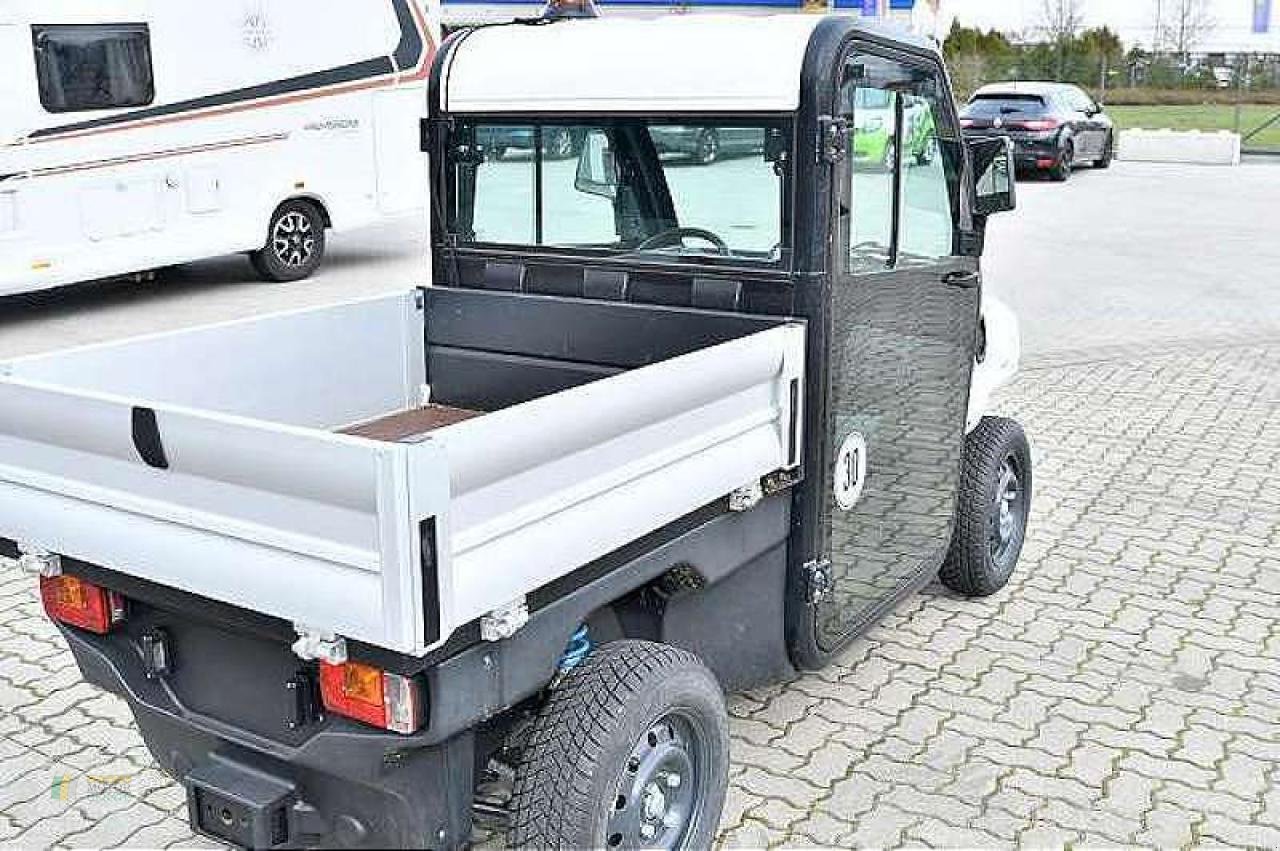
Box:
[840,62,897,274]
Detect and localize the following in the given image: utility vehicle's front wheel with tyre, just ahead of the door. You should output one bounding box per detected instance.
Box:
[938,417,1032,596]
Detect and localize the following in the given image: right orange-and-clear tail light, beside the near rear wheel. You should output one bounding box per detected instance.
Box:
[320,662,424,733]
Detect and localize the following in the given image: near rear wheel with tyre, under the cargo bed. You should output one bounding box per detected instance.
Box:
[508,641,728,848]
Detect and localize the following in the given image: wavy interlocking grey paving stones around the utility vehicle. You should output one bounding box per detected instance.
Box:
[0,343,1280,847]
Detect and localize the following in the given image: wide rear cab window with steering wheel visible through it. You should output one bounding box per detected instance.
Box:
[449,119,790,264]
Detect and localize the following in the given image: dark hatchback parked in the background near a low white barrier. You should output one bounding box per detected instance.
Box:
[960,82,1115,180]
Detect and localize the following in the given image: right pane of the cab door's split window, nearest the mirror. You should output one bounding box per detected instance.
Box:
[897,78,957,265]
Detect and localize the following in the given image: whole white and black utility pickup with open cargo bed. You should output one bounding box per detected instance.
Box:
[0,15,1032,848]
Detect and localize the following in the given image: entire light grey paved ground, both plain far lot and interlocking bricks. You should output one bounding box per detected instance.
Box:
[0,157,1280,848]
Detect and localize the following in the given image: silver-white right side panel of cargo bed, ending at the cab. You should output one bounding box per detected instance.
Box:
[435,325,804,626]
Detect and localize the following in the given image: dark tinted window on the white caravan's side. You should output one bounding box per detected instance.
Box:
[31,23,155,113]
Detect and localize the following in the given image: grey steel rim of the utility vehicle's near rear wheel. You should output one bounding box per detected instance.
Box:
[604,710,710,848]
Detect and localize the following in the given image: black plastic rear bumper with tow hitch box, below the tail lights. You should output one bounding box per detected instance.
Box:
[61,627,474,848]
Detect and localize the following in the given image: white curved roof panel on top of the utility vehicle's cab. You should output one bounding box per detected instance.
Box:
[442,14,822,113]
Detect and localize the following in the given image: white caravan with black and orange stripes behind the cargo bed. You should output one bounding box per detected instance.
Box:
[0,0,439,296]
